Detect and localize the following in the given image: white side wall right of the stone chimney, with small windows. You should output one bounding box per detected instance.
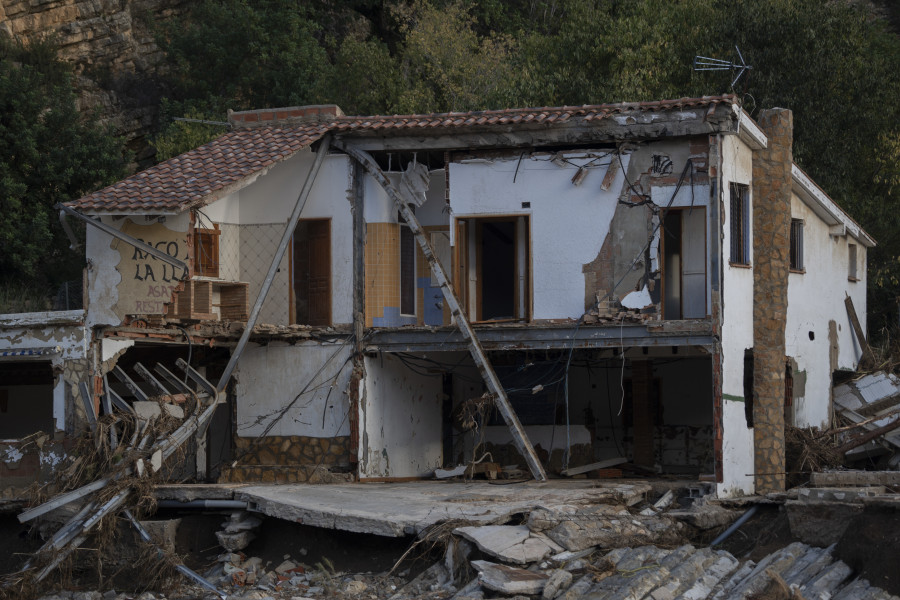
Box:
[785,194,866,427]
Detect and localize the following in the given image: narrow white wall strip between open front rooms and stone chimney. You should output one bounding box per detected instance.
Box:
[717,136,754,496]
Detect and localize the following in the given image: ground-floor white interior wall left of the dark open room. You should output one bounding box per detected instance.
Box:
[359,354,443,479]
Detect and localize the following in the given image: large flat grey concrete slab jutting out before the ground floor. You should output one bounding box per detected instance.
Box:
[227,480,650,537]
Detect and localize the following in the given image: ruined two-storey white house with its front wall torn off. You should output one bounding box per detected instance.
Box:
[0,95,874,496]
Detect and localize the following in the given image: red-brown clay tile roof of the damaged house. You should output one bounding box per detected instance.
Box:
[67,94,736,214]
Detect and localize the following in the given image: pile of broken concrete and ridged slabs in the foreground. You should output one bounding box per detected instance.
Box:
[26,492,900,600]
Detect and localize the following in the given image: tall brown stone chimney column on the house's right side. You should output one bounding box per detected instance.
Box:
[752,108,793,494]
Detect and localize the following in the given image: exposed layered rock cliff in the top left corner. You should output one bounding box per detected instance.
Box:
[0,0,190,162]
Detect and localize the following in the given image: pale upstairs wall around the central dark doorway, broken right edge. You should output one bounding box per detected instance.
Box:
[450,150,630,319]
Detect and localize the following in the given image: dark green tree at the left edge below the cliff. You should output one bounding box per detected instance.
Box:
[0,37,125,286]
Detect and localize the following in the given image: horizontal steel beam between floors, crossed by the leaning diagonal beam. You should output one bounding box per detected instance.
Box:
[366,325,715,352]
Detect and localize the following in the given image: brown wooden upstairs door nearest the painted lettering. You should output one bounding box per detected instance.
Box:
[293,219,331,326]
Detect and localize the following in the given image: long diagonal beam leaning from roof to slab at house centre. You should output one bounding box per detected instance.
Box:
[332,140,547,481]
